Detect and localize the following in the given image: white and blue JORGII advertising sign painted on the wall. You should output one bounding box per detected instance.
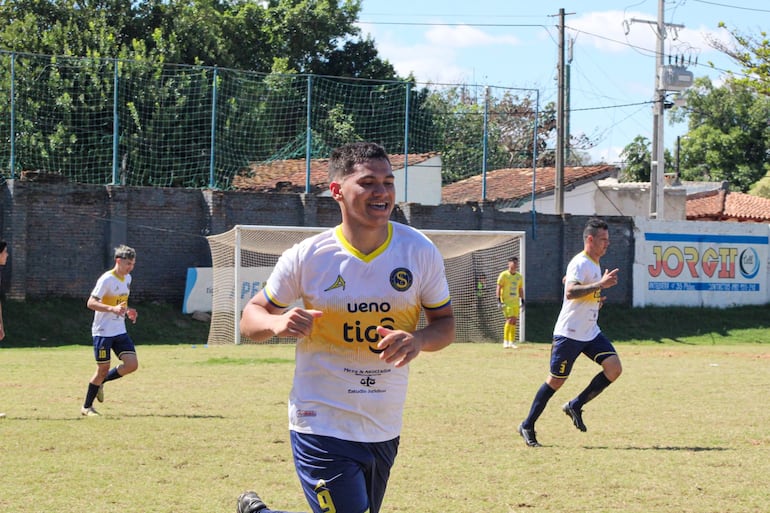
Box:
[632,217,770,308]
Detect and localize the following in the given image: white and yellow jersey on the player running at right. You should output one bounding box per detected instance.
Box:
[553,251,602,341]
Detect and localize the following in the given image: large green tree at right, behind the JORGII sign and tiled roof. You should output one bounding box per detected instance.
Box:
[671,77,770,192]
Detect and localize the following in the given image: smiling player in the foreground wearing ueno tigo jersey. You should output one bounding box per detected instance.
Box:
[237,143,455,513]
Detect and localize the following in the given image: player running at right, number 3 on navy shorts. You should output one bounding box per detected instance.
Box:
[519,218,623,447]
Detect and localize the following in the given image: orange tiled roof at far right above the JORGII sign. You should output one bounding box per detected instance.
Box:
[686,189,770,223]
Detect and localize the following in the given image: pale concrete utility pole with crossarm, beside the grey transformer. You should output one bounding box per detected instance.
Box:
[631,0,684,219]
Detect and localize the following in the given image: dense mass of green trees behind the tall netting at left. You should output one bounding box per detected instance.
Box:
[0,0,544,187]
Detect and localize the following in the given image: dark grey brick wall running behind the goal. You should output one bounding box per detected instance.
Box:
[0,180,634,305]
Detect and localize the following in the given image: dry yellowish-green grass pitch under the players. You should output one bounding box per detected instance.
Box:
[0,332,770,513]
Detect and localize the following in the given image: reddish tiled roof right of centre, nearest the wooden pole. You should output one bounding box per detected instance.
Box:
[441,165,618,203]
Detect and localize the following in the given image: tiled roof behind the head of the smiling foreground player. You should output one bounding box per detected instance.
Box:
[233,153,438,192]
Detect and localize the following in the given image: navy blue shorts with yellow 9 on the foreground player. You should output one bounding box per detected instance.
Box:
[290,431,399,513]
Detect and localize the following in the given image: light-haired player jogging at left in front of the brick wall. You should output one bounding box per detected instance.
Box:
[80,245,139,417]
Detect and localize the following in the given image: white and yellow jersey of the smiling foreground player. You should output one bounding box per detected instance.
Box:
[263,223,450,442]
